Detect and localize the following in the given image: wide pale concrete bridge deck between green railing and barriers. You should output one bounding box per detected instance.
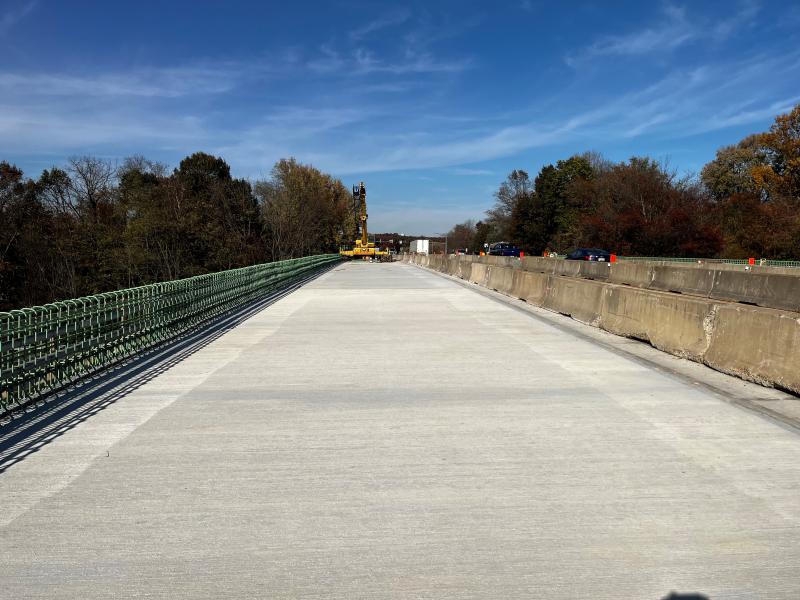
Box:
[0,263,800,600]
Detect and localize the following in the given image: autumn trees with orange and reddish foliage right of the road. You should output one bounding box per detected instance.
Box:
[448,105,800,259]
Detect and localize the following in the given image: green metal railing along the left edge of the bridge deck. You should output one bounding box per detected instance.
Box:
[0,254,341,416]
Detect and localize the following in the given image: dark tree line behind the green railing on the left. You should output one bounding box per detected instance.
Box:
[0,152,355,310]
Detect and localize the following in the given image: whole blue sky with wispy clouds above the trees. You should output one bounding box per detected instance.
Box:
[0,0,800,234]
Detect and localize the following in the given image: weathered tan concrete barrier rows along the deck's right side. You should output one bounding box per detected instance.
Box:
[404,256,800,393]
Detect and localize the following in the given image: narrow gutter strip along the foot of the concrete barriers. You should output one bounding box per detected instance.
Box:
[410,263,800,435]
